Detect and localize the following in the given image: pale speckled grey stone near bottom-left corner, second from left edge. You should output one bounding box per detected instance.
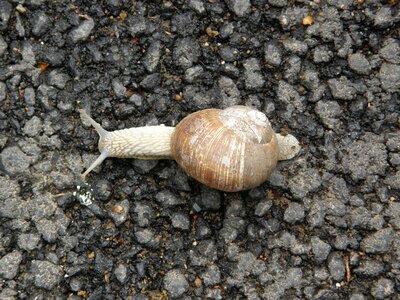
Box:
[30,260,64,290]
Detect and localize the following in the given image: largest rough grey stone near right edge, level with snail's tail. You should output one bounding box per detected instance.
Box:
[342,139,388,181]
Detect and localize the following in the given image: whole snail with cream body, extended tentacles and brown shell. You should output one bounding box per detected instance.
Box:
[79,105,300,192]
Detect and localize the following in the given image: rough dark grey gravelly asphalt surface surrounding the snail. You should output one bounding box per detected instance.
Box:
[0,0,400,300]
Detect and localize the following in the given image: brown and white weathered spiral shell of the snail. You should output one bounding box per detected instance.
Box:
[171,106,278,192]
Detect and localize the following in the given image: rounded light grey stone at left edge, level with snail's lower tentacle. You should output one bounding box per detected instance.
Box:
[0,146,31,175]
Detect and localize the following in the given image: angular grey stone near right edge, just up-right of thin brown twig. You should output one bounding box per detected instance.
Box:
[361,228,394,254]
